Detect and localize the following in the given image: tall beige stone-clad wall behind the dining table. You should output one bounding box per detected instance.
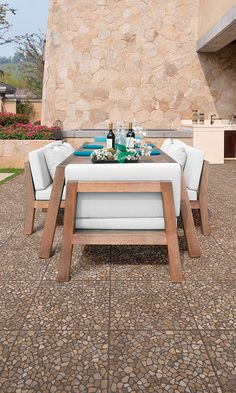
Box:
[42,0,236,129]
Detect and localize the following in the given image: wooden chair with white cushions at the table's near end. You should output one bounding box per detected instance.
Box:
[57,163,182,282]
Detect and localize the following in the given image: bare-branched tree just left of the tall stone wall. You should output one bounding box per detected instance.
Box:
[15,33,45,97]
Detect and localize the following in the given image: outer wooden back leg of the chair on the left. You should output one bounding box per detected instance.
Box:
[24,162,35,235]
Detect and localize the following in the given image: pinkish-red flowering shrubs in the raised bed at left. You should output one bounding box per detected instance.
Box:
[0,112,58,140]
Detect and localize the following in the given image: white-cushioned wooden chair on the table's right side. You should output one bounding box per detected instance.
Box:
[161,138,210,236]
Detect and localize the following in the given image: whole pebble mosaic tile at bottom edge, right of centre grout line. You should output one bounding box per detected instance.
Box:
[110,329,221,393]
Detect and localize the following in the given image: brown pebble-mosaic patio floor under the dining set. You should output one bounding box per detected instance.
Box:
[0,162,236,393]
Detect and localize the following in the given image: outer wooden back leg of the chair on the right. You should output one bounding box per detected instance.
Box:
[199,161,210,236]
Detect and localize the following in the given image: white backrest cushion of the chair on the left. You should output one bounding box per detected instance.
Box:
[29,141,62,191]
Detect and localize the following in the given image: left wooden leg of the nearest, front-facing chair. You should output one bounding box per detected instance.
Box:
[57,182,77,282]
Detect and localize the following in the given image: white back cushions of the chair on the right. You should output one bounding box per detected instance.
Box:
[161,139,204,191]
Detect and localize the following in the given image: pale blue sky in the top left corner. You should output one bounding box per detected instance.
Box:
[0,0,49,57]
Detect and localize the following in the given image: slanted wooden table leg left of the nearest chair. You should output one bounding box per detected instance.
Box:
[39,166,65,259]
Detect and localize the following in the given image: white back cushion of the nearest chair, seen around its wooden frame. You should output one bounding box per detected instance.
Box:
[65,163,181,229]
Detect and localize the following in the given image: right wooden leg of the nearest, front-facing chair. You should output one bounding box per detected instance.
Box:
[161,182,182,283]
